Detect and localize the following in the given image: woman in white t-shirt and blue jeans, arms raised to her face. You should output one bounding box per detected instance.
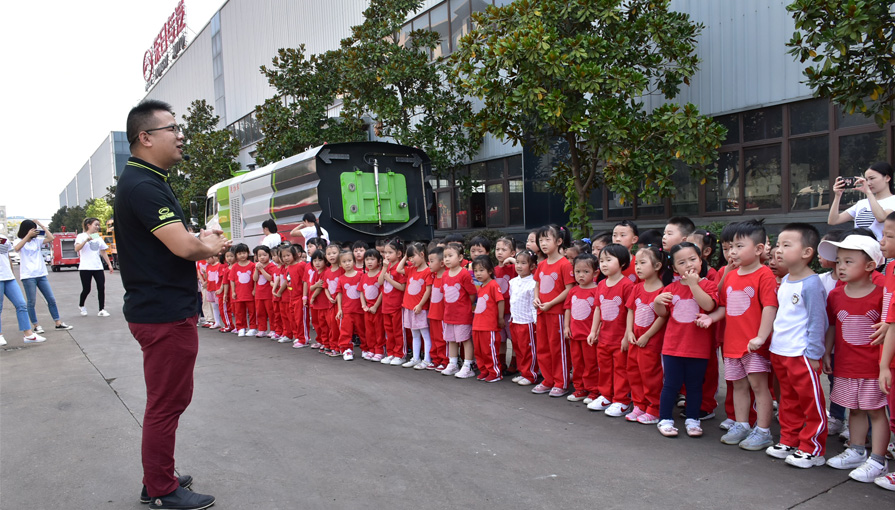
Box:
[15,220,71,333]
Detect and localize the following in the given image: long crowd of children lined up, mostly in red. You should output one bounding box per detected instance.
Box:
[200,217,895,490]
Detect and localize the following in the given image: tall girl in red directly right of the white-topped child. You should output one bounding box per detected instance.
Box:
[531,225,575,397]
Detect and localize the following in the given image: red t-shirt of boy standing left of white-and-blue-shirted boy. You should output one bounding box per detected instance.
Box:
[718,266,777,358]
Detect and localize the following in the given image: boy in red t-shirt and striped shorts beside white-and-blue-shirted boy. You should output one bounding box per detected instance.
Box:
[701,221,777,451]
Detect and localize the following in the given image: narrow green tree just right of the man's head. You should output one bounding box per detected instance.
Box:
[168,99,239,225]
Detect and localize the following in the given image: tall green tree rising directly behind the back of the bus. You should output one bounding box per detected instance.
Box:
[338,0,482,174]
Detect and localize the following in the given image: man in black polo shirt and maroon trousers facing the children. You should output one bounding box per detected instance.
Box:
[115,100,230,510]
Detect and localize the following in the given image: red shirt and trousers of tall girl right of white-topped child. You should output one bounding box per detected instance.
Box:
[534,257,575,391]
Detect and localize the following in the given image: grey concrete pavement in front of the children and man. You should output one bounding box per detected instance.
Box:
[0,271,895,510]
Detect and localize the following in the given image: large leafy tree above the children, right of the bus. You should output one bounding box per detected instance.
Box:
[452,0,725,235]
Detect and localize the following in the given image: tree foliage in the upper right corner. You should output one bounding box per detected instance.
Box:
[786,0,895,127]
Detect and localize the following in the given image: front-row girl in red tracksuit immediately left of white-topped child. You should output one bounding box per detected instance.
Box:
[472,255,504,382]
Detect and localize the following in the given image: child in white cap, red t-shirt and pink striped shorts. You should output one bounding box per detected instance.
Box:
[818,234,889,483]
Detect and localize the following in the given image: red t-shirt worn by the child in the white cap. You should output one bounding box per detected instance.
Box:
[827,287,883,379]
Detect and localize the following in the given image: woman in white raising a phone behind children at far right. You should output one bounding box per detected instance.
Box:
[827,161,895,239]
